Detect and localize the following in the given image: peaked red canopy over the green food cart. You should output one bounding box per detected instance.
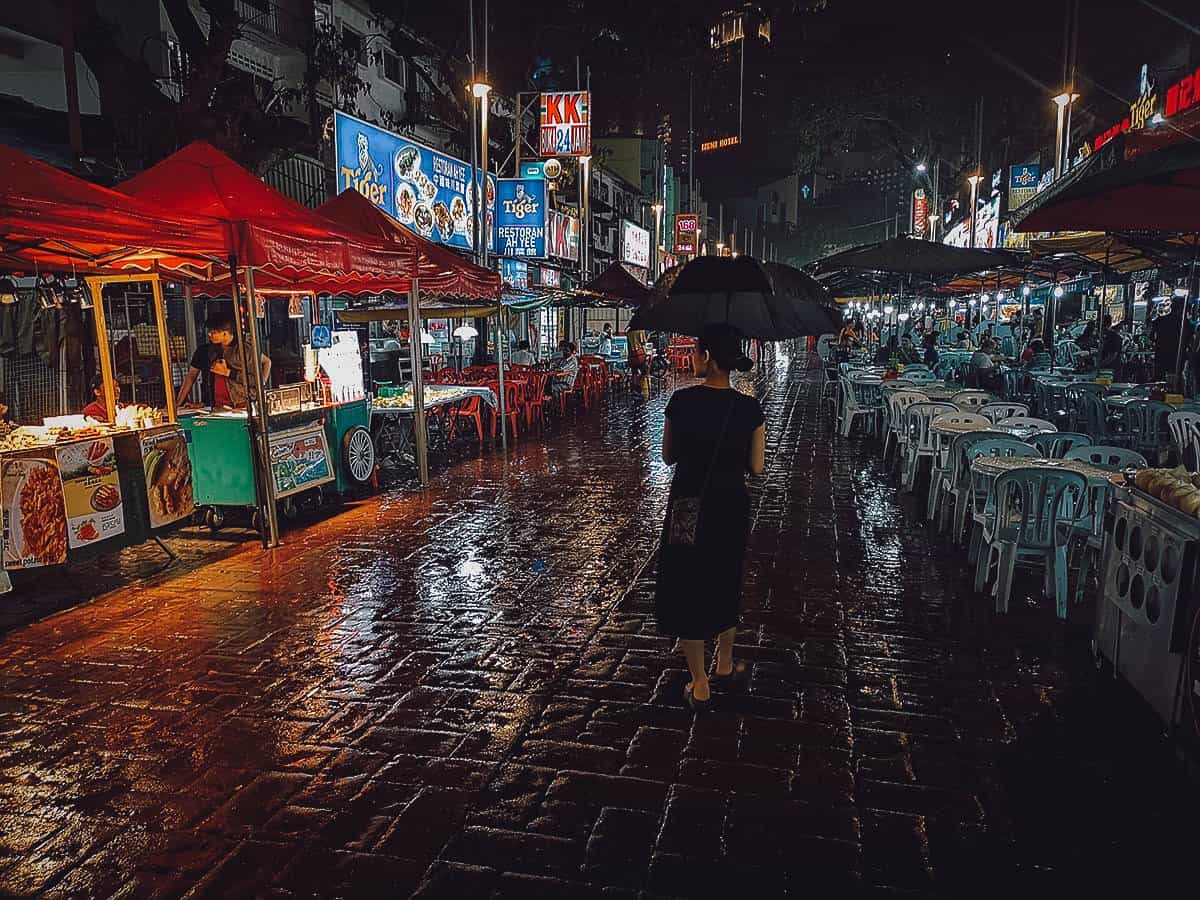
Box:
[118,142,424,293]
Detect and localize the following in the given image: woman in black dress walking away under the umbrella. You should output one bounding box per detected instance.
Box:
[654,325,766,710]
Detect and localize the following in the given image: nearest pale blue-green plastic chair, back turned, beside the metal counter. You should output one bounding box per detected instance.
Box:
[976,467,1091,619]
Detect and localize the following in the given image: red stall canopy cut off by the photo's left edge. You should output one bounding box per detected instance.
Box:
[0,145,227,275]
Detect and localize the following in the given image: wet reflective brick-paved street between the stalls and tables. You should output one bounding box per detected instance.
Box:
[0,355,1196,900]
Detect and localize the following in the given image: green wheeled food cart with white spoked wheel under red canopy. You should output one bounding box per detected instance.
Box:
[180,331,376,530]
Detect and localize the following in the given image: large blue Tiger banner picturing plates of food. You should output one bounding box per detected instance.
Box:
[334,110,496,250]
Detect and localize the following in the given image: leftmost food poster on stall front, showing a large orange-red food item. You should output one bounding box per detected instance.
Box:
[0,458,67,569]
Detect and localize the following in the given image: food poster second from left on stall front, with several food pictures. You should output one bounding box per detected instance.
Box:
[54,438,125,550]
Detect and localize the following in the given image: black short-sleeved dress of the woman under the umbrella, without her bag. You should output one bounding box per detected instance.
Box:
[654,385,763,640]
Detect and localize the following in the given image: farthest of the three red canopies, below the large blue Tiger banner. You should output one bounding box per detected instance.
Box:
[317,190,500,300]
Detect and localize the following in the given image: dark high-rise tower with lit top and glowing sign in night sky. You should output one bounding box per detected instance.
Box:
[695,4,770,190]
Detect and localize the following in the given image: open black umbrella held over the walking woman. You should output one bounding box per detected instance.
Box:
[629,256,840,341]
